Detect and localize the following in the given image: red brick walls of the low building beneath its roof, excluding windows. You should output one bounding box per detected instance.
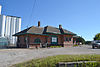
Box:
[17,34,73,47]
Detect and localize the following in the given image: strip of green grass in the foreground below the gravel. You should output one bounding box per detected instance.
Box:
[11,55,100,67]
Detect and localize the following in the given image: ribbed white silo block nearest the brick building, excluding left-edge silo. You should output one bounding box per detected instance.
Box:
[5,16,21,44]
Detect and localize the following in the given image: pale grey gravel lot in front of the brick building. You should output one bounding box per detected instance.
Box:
[0,46,100,67]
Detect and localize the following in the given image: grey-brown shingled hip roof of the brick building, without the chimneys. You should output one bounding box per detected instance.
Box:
[14,26,76,36]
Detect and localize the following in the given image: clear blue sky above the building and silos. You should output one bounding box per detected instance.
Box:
[0,0,100,40]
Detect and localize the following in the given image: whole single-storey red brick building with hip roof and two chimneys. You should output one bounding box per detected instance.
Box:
[14,21,76,48]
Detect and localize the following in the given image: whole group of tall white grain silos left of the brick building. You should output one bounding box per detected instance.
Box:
[0,5,21,44]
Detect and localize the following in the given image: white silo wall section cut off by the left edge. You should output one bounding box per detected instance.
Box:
[0,15,6,37]
